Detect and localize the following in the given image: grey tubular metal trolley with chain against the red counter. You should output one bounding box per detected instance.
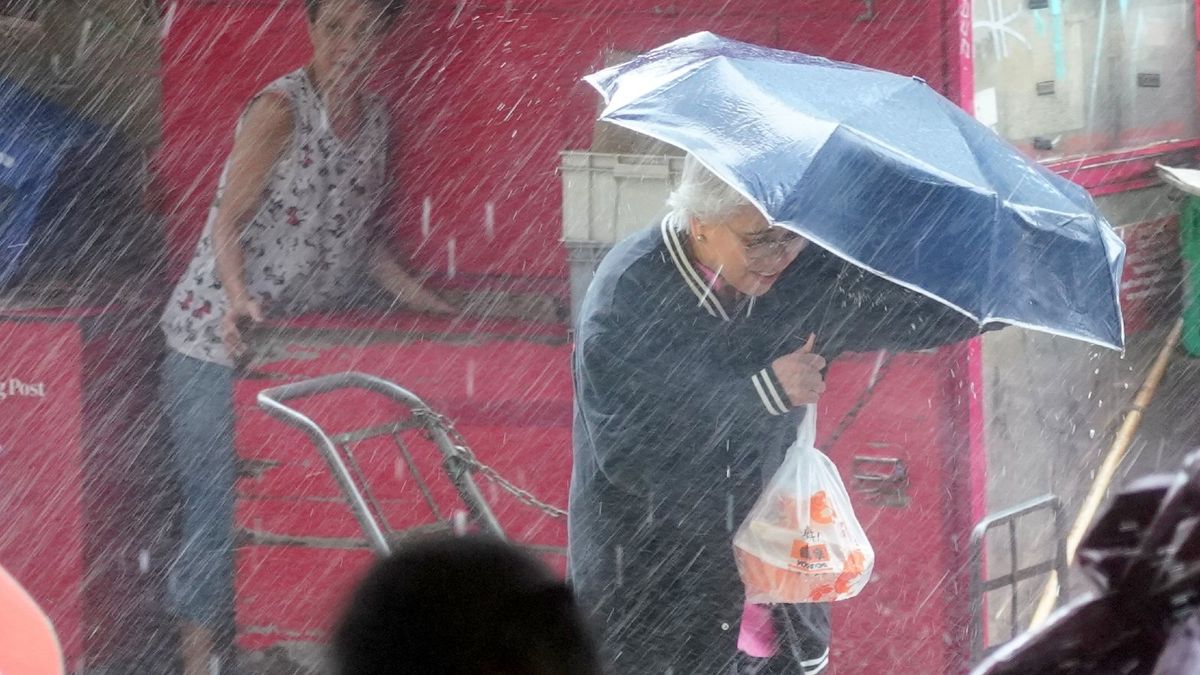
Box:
[258,372,566,556]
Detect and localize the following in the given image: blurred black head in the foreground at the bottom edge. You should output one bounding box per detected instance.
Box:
[332,536,600,675]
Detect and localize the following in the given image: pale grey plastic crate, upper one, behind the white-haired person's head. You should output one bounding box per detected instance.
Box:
[562,151,683,244]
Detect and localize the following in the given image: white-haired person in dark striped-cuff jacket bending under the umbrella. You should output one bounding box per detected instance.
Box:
[569,156,978,675]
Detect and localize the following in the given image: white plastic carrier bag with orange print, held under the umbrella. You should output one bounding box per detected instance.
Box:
[733,405,875,604]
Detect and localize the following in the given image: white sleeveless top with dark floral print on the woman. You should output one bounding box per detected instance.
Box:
[161,68,388,365]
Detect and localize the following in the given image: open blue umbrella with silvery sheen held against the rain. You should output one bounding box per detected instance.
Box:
[586,32,1124,350]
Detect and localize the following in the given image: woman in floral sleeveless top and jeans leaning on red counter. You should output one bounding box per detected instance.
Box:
[161,0,455,675]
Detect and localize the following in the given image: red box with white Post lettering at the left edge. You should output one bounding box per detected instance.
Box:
[0,305,172,673]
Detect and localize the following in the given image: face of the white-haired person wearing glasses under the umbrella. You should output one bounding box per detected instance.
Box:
[700,207,808,295]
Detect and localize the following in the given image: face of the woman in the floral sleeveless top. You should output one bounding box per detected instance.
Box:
[308,0,388,91]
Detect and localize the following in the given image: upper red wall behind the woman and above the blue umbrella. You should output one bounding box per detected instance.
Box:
[158,0,948,277]
